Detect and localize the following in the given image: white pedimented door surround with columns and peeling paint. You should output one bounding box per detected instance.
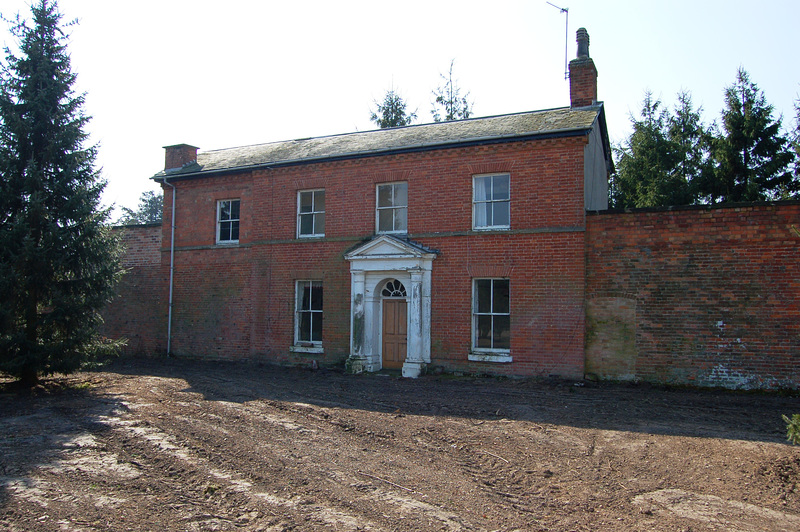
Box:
[344,235,436,378]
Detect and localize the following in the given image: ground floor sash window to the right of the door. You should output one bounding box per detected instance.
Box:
[472,279,511,353]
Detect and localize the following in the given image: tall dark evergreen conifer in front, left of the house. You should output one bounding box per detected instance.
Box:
[0,0,120,385]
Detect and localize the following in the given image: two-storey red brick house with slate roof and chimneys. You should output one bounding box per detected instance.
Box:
[153,30,613,377]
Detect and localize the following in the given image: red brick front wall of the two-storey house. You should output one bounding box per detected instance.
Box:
[163,137,585,377]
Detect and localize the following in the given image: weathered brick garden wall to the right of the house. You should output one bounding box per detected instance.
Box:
[586,203,800,389]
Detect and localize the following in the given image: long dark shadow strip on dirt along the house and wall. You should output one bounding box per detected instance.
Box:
[106,358,800,443]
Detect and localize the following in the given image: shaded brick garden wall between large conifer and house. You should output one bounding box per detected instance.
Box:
[101,224,169,355]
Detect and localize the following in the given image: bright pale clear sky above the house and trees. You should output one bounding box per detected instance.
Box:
[0,0,800,216]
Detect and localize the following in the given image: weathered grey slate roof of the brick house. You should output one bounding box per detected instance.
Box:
[154,104,605,179]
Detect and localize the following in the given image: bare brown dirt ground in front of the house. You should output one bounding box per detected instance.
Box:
[0,359,800,531]
